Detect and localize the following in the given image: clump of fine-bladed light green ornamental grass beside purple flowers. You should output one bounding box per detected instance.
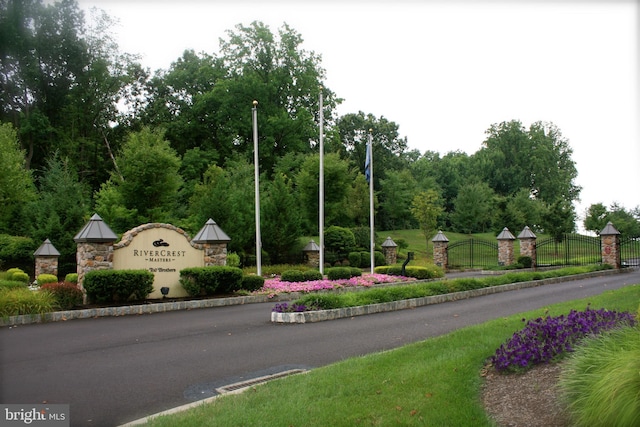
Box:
[560,326,640,427]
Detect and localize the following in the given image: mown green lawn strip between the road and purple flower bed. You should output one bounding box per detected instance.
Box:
[142,285,640,427]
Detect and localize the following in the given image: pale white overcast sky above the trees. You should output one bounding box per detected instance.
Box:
[78,0,640,227]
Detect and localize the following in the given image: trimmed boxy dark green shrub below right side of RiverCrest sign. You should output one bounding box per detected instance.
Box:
[180,266,242,296]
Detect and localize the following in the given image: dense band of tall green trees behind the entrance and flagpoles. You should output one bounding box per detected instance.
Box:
[0,0,640,274]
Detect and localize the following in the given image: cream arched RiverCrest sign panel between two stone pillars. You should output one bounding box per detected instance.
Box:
[113,224,204,298]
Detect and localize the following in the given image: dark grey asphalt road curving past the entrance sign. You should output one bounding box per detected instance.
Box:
[0,269,640,427]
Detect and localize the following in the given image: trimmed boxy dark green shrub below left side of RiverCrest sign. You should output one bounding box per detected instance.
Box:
[83,270,153,304]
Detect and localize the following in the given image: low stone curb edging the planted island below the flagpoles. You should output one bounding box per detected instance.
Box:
[271,270,625,323]
